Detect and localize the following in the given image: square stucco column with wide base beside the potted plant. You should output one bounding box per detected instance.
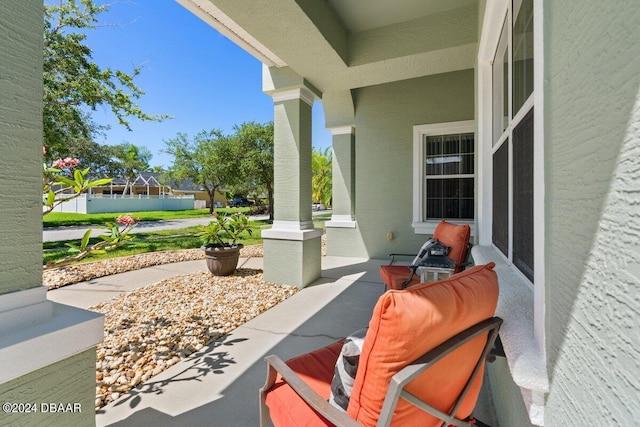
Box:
[262,69,322,288]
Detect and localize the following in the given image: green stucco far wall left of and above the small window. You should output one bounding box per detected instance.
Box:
[350,70,474,258]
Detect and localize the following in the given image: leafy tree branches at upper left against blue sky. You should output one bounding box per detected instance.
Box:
[43,0,168,162]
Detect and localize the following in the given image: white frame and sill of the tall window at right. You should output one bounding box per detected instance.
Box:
[472,0,549,425]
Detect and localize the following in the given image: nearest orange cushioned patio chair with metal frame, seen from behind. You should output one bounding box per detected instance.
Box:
[260,263,502,427]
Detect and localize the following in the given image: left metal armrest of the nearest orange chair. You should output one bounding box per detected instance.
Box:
[260,355,362,427]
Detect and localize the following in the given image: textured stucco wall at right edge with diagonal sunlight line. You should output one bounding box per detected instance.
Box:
[543,0,640,426]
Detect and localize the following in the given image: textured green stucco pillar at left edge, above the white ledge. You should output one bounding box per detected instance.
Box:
[0,0,43,294]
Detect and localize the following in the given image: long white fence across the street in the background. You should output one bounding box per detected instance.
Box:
[54,194,195,213]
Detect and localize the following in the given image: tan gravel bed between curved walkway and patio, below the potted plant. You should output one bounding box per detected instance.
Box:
[90,269,297,408]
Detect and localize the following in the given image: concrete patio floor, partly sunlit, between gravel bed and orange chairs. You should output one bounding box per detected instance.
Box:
[50,257,496,427]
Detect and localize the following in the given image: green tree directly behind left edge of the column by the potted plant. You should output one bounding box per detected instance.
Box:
[233,122,273,220]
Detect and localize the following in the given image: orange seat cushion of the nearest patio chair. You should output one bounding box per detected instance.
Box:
[266,340,344,427]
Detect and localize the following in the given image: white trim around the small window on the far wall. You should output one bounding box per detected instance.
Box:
[411,120,478,235]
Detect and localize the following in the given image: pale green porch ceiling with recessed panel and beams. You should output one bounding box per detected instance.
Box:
[178,0,479,93]
